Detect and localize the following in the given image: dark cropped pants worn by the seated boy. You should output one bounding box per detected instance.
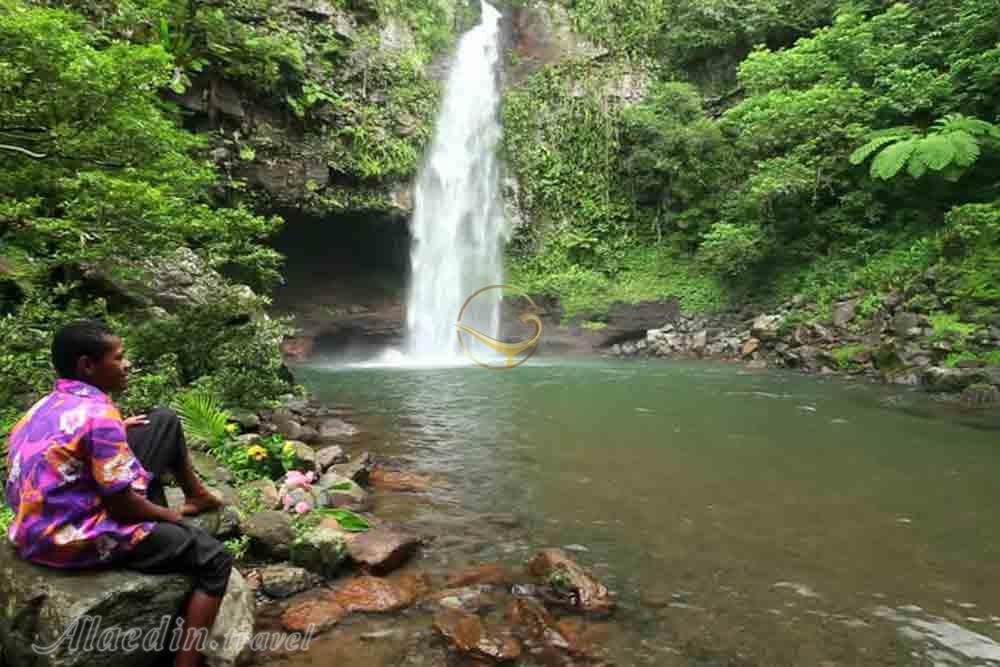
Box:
[122,408,233,597]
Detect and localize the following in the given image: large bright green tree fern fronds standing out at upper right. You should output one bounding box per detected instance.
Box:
[850,114,1000,180]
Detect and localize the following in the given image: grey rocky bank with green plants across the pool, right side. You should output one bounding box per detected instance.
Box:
[602,292,1000,407]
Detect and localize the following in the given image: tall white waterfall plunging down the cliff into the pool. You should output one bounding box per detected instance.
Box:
[406,2,507,360]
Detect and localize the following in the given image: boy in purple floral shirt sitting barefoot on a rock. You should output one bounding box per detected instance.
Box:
[6,321,233,667]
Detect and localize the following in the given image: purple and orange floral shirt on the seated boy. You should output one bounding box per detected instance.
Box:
[6,379,155,568]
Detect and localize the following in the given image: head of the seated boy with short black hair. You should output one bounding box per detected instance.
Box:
[52,320,131,392]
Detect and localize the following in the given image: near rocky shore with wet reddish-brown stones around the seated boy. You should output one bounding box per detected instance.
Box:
[0,396,615,667]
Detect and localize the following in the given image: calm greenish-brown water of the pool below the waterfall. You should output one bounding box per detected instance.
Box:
[288,361,1000,665]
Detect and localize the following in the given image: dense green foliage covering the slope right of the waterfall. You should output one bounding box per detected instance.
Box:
[505,0,1000,321]
